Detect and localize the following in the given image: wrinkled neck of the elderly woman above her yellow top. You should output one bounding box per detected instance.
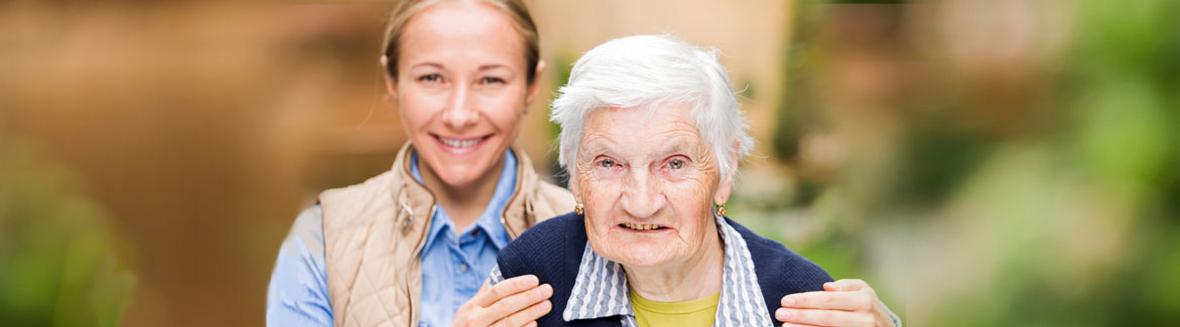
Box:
[623,224,725,302]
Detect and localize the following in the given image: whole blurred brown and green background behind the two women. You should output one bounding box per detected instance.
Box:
[0,0,1180,326]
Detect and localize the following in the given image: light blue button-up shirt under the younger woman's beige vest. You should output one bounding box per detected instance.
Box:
[267,150,517,326]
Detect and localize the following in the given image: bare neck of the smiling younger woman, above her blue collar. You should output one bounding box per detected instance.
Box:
[418,152,504,230]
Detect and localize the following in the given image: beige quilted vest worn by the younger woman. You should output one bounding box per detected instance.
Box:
[320,144,573,327]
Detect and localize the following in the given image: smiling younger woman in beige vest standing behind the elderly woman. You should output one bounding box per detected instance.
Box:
[267,0,892,326]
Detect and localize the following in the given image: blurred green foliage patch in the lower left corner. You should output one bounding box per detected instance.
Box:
[0,139,136,326]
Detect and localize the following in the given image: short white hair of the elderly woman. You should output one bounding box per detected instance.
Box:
[550,35,754,178]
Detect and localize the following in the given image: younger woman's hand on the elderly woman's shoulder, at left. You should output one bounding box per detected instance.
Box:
[451,275,553,327]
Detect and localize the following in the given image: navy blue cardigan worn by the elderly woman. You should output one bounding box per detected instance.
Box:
[497,212,832,326]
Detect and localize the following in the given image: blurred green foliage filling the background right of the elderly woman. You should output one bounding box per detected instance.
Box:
[772,0,1180,326]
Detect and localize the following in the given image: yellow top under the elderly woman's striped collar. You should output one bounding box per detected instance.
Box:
[631,289,721,327]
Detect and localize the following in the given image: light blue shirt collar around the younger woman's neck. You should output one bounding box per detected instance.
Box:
[420,149,517,253]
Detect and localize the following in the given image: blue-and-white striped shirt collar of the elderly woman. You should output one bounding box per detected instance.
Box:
[562,216,773,326]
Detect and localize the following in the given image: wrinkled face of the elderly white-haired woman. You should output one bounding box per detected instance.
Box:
[571,105,728,267]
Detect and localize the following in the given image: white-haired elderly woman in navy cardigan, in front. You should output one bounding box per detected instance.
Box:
[477,35,892,327]
